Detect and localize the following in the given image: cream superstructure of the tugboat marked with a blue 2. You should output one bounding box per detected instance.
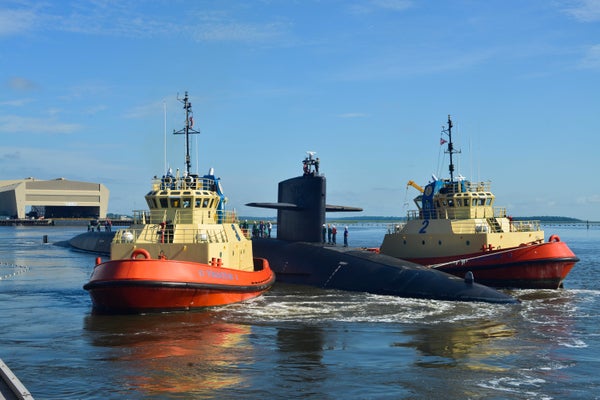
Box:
[380,181,544,259]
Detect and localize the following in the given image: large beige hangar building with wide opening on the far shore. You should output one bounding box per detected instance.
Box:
[0,178,109,219]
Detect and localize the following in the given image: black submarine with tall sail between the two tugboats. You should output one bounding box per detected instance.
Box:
[246,152,519,303]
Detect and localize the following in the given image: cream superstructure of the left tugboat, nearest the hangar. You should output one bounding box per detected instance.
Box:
[111,176,254,271]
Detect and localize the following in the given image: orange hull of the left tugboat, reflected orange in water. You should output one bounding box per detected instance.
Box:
[84,258,275,313]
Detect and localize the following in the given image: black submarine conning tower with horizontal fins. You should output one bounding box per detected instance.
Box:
[246,151,362,243]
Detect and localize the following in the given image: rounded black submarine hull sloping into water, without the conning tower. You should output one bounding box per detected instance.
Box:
[252,238,518,303]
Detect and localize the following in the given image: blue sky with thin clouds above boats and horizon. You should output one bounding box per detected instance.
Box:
[0,0,600,221]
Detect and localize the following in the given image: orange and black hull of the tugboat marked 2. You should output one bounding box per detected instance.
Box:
[408,241,579,289]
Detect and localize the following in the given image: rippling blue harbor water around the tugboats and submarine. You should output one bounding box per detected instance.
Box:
[0,224,600,400]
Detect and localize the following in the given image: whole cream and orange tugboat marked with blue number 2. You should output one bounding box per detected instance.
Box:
[380,116,579,289]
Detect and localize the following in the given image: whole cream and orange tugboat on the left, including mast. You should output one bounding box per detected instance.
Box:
[83,92,275,313]
